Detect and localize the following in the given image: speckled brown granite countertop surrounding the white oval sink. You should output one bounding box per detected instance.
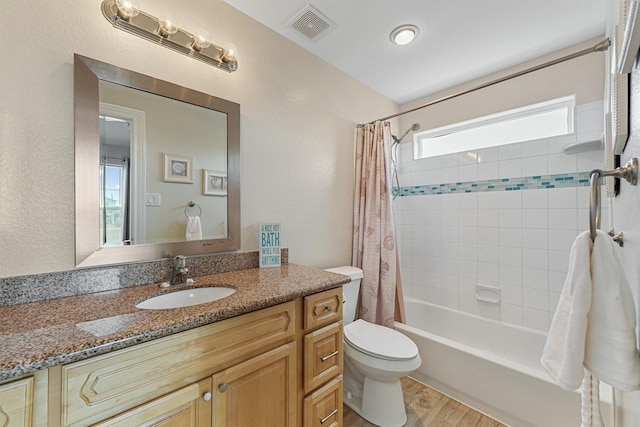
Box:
[0,264,349,382]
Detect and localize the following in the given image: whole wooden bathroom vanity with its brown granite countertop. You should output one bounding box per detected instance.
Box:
[0,264,349,426]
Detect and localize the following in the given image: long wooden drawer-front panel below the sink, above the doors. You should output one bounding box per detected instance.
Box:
[57,301,296,426]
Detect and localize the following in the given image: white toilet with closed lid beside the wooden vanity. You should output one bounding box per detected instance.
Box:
[327,266,422,427]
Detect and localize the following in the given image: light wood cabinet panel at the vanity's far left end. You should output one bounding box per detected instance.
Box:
[0,378,33,427]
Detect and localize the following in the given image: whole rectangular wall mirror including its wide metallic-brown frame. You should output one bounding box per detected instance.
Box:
[74,55,240,266]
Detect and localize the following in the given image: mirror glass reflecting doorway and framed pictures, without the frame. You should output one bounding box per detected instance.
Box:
[99,81,227,246]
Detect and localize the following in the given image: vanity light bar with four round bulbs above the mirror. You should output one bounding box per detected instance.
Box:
[101,0,238,73]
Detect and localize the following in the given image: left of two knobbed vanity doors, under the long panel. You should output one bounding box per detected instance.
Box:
[94,378,211,427]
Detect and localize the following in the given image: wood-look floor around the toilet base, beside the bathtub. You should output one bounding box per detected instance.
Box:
[344,377,507,427]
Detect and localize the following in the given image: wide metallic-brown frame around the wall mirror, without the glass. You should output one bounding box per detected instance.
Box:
[74,54,240,267]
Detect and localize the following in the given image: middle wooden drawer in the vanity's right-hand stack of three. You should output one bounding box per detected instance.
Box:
[304,322,343,393]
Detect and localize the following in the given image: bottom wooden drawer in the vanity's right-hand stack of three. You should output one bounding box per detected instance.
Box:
[304,375,342,427]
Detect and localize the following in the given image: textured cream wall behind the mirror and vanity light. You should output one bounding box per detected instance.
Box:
[0,0,398,277]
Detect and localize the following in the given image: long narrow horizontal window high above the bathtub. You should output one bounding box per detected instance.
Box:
[414,96,575,159]
